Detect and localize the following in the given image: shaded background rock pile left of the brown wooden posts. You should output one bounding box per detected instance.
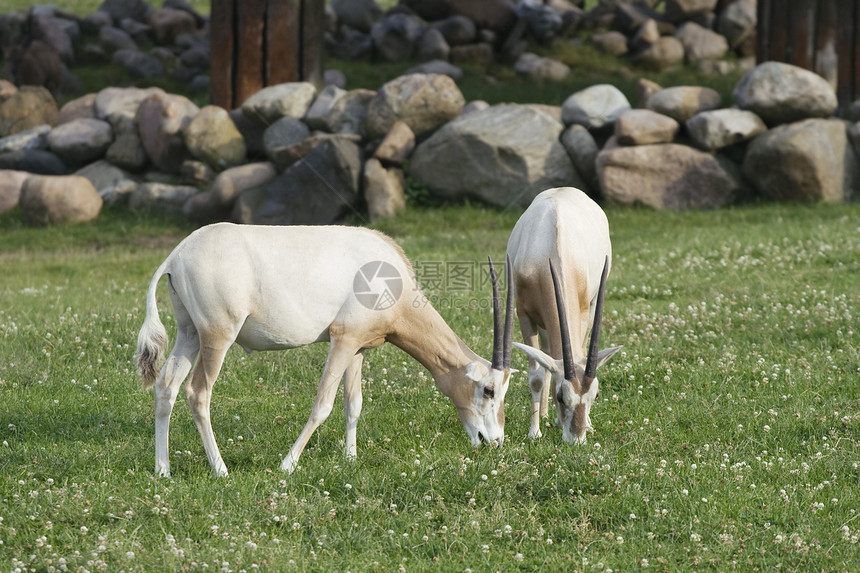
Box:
[0,0,209,95]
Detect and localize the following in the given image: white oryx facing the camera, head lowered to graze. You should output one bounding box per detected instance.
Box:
[507,187,621,444]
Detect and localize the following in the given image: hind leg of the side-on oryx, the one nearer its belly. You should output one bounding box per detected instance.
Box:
[185,337,230,477]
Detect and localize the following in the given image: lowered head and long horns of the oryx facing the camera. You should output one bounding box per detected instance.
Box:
[515,257,621,444]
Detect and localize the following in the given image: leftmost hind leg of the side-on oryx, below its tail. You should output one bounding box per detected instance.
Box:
[153,327,200,477]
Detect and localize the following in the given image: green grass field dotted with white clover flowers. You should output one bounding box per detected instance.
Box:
[0,200,860,571]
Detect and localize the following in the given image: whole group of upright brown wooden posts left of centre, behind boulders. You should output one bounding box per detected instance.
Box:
[210,0,325,109]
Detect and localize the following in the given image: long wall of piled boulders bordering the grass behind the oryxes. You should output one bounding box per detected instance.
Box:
[0,62,860,224]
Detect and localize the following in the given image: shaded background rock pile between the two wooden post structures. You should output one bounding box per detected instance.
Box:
[326,0,756,81]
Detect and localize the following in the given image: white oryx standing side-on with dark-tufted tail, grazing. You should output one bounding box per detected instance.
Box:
[136,223,512,476]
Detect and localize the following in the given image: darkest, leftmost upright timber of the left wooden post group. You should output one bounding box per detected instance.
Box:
[209,0,235,109]
